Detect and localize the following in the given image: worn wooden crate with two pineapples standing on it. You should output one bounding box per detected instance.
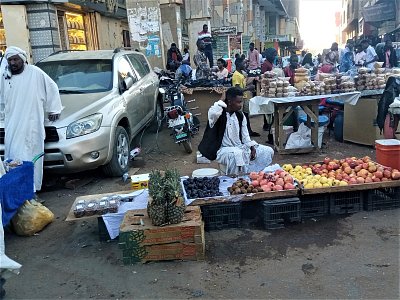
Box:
[119,206,205,264]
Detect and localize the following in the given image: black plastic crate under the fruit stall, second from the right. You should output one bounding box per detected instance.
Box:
[329,191,364,215]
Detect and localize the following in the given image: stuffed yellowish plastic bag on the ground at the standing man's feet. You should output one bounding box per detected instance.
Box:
[11,200,54,236]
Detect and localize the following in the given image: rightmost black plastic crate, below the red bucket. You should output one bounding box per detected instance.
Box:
[364,187,400,211]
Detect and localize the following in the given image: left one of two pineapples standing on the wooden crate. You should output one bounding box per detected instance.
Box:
[147,170,167,226]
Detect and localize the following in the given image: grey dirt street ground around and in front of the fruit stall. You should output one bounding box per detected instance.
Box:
[5,113,400,299]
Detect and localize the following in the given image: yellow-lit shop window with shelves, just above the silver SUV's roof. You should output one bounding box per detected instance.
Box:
[65,12,87,50]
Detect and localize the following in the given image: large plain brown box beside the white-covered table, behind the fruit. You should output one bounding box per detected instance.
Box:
[343,97,384,146]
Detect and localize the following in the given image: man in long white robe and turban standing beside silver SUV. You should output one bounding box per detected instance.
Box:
[0,47,62,192]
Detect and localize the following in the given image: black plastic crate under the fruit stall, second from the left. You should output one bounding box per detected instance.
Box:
[262,197,301,229]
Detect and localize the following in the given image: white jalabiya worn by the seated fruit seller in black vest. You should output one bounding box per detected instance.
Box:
[208,102,274,175]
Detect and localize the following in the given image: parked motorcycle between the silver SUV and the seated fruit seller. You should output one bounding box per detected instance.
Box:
[164,80,200,153]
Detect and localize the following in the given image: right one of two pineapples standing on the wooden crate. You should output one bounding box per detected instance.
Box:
[164,169,186,224]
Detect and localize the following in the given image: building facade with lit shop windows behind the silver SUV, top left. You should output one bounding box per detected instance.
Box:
[0,0,130,63]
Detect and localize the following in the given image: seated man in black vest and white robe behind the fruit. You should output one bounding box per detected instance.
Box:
[199,87,274,175]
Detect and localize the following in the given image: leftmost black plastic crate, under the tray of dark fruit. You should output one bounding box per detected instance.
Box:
[201,202,242,230]
